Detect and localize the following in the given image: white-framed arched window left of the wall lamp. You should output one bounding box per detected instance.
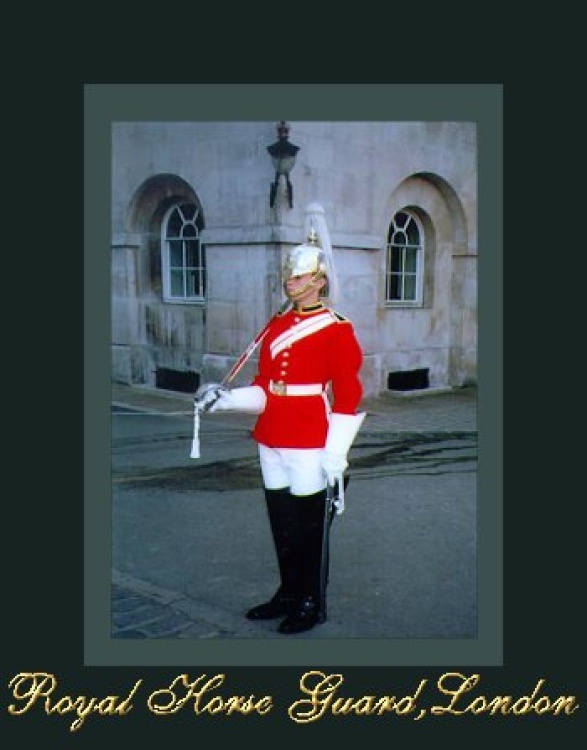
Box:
[161,203,206,302]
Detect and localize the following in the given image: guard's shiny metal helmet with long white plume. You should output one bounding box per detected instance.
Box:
[283,203,338,304]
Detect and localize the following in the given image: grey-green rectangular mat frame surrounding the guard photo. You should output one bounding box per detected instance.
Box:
[84,84,503,667]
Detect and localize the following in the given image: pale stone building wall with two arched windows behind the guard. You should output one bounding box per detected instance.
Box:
[111,121,477,396]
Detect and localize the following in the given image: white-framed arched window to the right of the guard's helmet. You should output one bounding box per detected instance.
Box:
[385,211,424,306]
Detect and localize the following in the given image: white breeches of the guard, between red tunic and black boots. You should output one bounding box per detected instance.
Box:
[259,444,326,495]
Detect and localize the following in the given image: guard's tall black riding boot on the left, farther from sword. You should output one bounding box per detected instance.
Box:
[246,488,300,620]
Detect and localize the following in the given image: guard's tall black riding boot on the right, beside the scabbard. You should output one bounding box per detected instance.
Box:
[278,490,329,633]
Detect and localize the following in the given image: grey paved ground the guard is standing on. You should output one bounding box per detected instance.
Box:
[112,384,477,639]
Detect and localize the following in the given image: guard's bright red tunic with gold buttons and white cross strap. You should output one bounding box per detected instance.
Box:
[252,305,363,448]
